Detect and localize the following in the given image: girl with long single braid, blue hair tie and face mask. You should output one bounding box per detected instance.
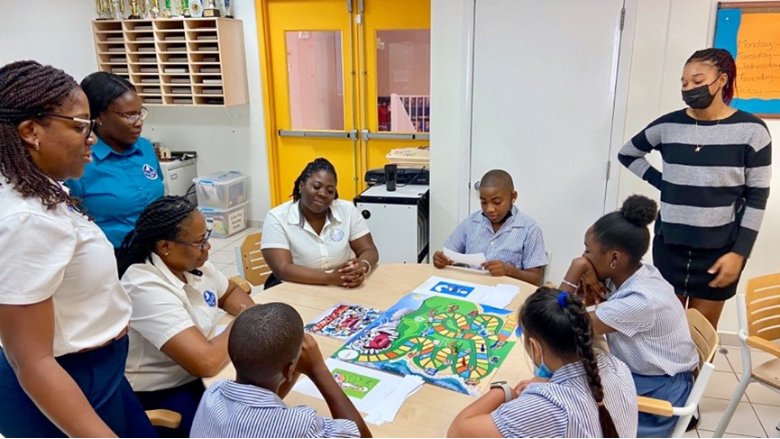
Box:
[448,287,637,437]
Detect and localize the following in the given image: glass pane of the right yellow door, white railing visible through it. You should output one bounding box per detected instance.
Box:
[376,29,431,133]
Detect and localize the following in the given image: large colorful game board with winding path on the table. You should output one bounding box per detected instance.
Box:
[333,293,517,395]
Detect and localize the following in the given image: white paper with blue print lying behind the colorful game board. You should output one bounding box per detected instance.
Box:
[414,276,520,308]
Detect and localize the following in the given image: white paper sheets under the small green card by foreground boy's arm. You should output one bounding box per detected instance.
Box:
[293,358,423,425]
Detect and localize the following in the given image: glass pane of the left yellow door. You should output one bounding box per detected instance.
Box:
[285,31,344,130]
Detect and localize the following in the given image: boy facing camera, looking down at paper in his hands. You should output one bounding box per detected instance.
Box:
[433,169,547,285]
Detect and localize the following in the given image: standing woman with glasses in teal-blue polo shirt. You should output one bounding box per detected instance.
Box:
[65,72,164,248]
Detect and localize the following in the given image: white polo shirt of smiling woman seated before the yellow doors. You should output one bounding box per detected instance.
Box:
[260,200,369,271]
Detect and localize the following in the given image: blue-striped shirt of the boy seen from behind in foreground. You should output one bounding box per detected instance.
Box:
[190,381,360,438]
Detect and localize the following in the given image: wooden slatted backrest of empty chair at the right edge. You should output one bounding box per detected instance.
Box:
[740,273,780,341]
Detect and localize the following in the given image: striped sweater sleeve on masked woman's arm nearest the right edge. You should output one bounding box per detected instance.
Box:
[732,122,772,257]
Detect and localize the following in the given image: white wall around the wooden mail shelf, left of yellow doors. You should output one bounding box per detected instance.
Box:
[0,0,271,221]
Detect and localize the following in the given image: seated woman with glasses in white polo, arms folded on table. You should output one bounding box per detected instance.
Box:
[117,196,254,437]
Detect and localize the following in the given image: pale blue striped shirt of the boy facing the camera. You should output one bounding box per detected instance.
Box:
[444,206,547,270]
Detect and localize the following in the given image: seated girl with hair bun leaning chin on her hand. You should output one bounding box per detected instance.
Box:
[560,195,699,437]
